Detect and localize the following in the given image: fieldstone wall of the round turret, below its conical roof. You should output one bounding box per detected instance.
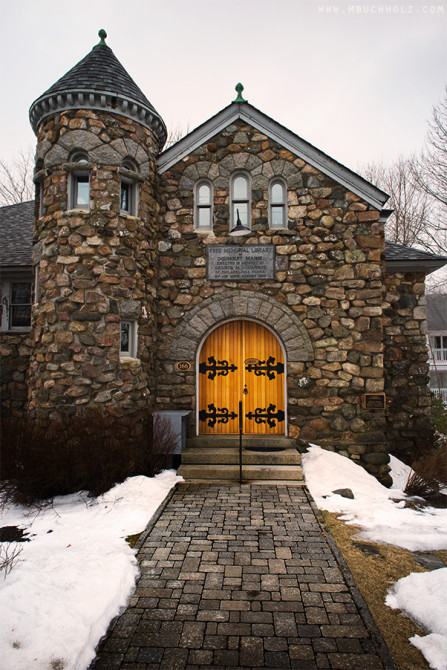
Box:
[30,110,158,421]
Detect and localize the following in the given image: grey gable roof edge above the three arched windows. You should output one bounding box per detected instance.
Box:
[158,102,389,209]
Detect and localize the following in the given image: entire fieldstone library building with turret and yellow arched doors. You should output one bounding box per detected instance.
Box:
[0,31,447,482]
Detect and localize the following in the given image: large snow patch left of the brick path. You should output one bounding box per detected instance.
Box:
[0,470,181,670]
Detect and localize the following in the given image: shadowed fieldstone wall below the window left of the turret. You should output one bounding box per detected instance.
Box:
[0,332,31,418]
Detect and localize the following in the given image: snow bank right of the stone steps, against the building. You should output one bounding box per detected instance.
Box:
[302,445,447,551]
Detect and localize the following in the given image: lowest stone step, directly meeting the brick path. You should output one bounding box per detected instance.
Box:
[178,464,304,482]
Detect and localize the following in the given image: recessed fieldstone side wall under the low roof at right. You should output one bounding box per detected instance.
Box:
[383,273,433,464]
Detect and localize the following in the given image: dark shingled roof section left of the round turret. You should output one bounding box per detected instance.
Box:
[0,200,34,267]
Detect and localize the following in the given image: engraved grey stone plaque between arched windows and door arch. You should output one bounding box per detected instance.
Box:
[207,244,275,281]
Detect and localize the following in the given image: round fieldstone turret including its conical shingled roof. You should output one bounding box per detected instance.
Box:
[29,31,166,422]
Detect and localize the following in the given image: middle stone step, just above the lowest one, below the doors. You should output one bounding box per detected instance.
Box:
[182,447,301,465]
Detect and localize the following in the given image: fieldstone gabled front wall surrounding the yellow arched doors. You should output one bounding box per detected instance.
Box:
[157,121,390,483]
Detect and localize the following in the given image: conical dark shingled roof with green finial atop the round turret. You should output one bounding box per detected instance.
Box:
[30,30,167,149]
